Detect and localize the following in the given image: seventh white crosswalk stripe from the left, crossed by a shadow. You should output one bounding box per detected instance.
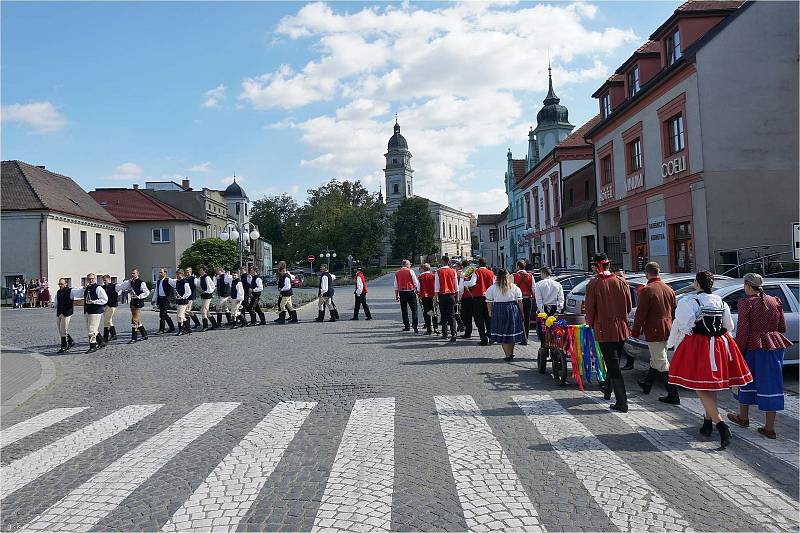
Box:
[514,394,690,531]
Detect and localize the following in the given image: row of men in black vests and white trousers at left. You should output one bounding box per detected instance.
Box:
[52,261,320,353]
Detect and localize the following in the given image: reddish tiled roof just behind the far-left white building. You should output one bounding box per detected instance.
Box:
[89,189,206,225]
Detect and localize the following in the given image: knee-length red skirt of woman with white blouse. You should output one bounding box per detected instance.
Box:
[669,333,753,390]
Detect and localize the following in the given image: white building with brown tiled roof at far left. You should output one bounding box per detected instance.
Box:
[0,161,126,288]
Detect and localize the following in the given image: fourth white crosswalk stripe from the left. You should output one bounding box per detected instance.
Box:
[162,402,316,532]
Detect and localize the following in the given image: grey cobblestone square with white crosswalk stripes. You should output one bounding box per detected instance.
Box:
[0,279,799,531]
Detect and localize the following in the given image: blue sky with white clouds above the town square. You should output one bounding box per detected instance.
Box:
[2,2,679,213]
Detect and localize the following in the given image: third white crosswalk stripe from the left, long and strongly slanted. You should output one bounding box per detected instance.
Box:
[23,402,239,531]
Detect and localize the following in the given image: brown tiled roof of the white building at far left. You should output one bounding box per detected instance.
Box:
[0,161,121,225]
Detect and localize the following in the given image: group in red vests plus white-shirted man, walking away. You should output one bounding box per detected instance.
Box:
[394,256,564,346]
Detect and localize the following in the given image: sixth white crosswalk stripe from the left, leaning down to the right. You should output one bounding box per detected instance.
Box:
[434,396,545,531]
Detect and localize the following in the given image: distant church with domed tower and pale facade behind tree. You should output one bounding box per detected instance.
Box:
[383,121,472,262]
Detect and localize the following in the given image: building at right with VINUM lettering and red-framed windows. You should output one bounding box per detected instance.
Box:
[586,1,799,272]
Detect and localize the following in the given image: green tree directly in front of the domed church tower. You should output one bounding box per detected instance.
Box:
[391,198,438,259]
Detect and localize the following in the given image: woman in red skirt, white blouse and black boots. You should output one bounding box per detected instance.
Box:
[667,272,753,448]
